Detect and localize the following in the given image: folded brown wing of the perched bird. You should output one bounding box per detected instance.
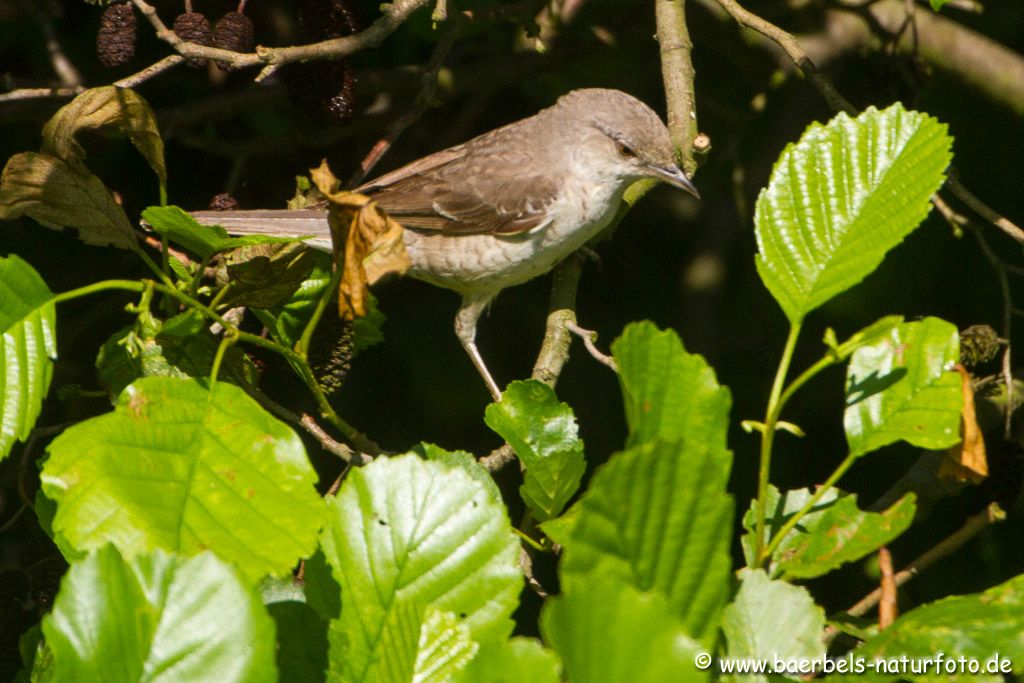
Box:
[356,138,558,234]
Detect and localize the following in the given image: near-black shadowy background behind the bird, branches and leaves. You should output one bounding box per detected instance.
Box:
[0,0,1024,674]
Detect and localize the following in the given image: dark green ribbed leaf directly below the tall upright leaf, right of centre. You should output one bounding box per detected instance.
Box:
[545,440,733,644]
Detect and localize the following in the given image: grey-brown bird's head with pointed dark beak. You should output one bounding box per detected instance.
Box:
[558,88,700,199]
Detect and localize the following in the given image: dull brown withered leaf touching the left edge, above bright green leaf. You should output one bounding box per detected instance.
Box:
[0,152,138,250]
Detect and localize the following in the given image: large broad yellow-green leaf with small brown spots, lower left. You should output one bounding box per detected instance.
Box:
[42,377,326,582]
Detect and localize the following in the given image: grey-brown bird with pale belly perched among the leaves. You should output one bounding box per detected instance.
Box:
[193,88,699,401]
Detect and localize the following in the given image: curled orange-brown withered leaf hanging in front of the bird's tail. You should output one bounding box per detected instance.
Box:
[310,162,410,321]
